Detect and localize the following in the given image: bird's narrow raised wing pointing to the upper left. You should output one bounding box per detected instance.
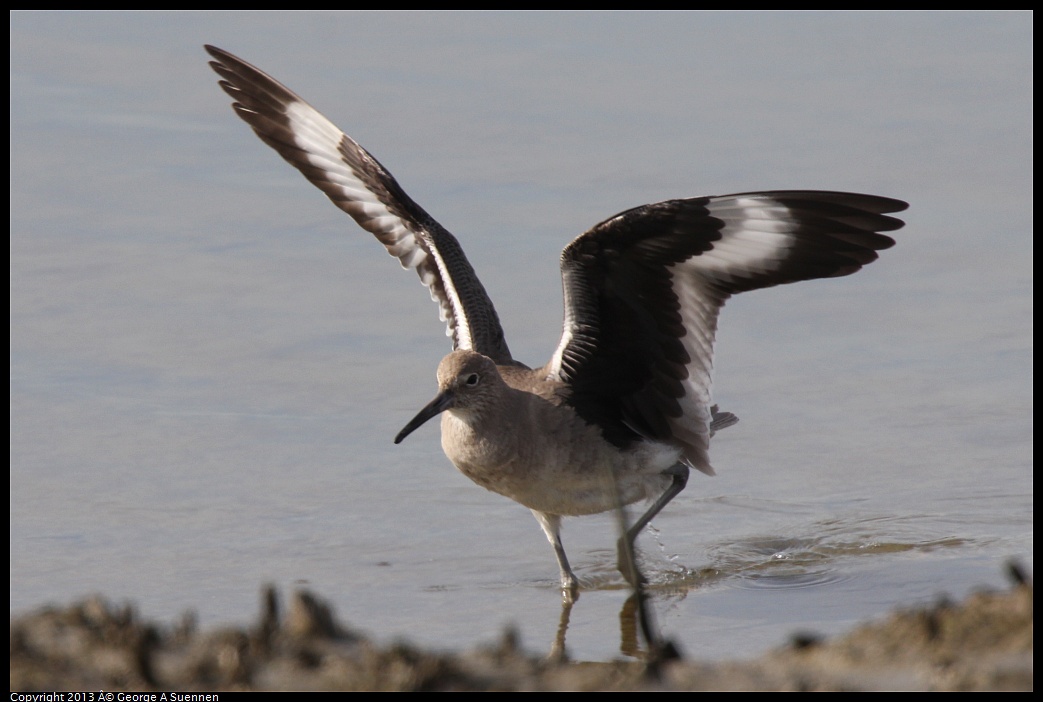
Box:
[205,46,512,364]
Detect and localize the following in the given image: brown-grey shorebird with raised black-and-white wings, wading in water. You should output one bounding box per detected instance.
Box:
[205,46,907,599]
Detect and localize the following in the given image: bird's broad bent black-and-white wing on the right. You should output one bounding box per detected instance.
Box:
[547,191,907,474]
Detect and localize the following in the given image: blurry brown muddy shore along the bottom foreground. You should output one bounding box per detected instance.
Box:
[10,567,1033,692]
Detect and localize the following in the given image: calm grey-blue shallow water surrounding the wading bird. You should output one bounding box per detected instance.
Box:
[10,13,1033,659]
